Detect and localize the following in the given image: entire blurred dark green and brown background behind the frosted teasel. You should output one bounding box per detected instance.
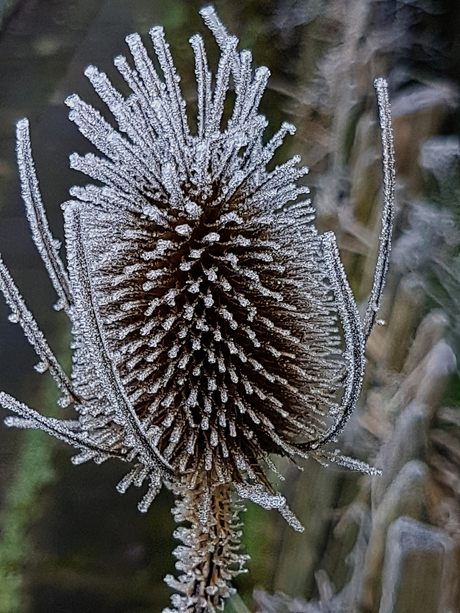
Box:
[0,0,460,613]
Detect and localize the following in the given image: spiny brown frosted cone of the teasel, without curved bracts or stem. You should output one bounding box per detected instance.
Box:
[67,10,341,482]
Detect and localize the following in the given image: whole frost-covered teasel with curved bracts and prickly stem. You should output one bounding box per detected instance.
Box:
[0,7,394,613]
